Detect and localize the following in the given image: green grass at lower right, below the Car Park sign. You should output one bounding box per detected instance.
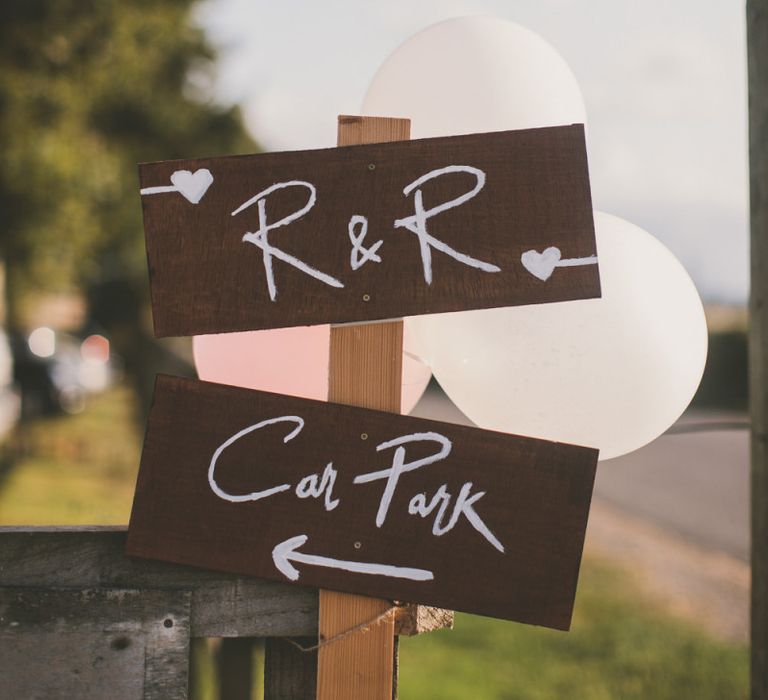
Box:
[400,558,748,700]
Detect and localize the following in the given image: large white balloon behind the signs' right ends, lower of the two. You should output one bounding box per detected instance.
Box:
[407,212,707,460]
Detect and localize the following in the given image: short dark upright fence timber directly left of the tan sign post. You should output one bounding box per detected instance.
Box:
[264,637,317,700]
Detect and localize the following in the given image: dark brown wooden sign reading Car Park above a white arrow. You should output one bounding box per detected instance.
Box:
[127,376,597,629]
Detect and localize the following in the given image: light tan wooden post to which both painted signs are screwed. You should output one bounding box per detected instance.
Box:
[317,116,410,700]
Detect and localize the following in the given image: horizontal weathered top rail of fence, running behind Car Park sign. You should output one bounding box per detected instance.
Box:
[0,527,450,637]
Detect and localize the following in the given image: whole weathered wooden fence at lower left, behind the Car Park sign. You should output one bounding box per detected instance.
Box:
[0,527,453,700]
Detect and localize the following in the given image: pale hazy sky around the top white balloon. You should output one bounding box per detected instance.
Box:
[197,0,749,303]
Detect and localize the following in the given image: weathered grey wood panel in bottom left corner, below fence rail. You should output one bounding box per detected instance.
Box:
[0,588,191,700]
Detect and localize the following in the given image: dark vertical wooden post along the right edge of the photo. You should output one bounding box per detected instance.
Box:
[747,0,768,700]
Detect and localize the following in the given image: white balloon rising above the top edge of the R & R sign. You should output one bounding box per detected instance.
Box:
[363,17,586,138]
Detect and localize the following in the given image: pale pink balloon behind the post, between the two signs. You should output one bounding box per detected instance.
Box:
[192,325,432,413]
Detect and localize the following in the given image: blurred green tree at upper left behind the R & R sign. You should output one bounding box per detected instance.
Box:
[0,0,255,418]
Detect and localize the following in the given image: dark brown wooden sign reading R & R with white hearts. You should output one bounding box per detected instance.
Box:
[140,124,600,336]
